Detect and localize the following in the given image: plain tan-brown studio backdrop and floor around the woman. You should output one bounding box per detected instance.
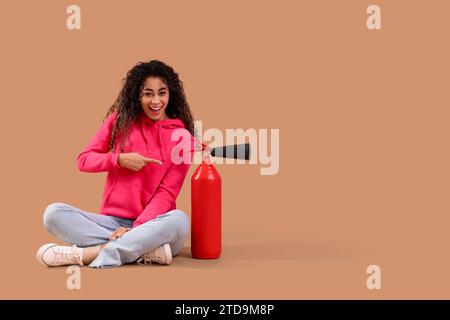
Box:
[0,0,450,299]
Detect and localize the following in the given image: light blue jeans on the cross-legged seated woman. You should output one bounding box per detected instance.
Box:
[44,203,189,268]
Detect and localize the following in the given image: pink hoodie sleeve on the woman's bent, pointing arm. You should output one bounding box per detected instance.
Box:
[77,112,120,172]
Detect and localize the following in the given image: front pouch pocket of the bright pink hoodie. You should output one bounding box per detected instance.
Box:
[106,183,151,217]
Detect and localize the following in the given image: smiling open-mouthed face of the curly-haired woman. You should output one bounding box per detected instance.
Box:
[140,77,169,121]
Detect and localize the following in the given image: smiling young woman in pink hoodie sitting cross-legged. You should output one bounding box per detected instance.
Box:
[37,60,194,268]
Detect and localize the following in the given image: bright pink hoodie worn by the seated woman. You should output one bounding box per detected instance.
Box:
[77,112,193,227]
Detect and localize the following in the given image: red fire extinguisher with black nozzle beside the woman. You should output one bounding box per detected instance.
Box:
[191,143,250,259]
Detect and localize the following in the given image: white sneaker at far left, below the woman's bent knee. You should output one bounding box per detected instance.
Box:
[36,243,83,267]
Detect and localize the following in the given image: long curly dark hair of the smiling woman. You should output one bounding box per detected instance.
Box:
[103,60,194,152]
